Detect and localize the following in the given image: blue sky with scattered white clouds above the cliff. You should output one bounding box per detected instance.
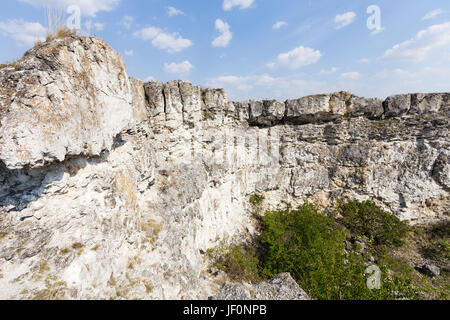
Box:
[0,0,450,100]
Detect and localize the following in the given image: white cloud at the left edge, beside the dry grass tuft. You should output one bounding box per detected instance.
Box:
[0,19,47,46]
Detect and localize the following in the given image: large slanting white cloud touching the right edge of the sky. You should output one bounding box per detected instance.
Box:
[382,22,450,61]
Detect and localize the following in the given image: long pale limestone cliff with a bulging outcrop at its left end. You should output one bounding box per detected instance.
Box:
[0,37,450,299]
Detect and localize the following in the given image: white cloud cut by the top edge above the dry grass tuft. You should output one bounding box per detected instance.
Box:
[19,0,120,17]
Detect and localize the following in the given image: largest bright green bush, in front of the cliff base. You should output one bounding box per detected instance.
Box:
[261,203,364,299]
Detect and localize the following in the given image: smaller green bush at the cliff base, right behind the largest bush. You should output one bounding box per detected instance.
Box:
[338,201,410,247]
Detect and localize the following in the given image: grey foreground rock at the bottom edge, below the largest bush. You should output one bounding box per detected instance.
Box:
[213,273,311,300]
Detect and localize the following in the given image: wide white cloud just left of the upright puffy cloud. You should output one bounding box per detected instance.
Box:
[133,27,193,53]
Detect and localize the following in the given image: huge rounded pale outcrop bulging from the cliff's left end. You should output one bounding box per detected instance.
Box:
[0,38,137,169]
